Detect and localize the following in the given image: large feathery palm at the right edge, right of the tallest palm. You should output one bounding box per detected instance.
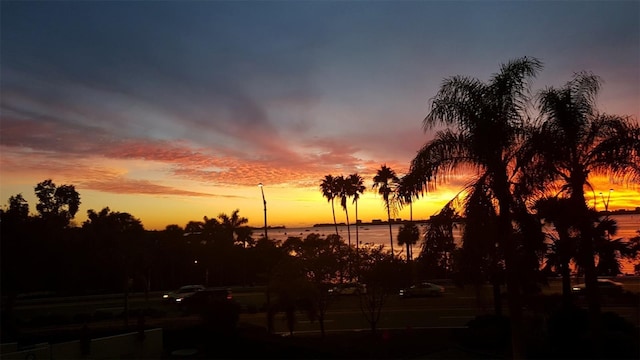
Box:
[525,72,640,332]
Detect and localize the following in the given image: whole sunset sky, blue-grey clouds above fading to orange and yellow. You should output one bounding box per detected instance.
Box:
[0,0,640,229]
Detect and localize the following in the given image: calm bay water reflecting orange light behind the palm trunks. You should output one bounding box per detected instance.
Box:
[268,214,640,274]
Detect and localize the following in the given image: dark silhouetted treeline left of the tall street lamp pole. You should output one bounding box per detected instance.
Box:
[0,180,264,295]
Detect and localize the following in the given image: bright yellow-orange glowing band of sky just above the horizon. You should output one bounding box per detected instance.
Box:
[2,173,640,230]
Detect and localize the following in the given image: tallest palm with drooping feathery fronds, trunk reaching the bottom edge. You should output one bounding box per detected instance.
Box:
[410,57,542,358]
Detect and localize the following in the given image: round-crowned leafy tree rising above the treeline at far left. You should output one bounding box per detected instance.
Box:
[35,179,80,228]
